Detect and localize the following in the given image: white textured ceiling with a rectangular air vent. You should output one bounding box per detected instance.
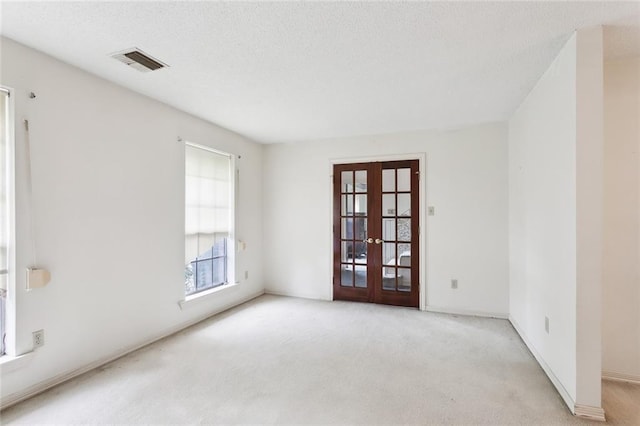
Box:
[0,1,640,142]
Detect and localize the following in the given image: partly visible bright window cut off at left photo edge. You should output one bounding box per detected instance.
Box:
[0,88,11,355]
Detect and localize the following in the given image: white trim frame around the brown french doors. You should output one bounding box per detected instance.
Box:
[327,152,428,311]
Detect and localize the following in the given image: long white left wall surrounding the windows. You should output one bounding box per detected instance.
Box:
[0,39,263,404]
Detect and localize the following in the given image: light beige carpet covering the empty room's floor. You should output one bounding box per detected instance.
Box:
[1,296,632,425]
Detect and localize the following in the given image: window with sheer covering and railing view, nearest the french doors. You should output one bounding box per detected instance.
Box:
[184,144,233,296]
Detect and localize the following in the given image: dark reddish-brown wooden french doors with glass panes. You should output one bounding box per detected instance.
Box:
[333,160,420,307]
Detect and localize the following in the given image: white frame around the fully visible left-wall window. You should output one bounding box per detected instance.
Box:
[182,141,239,301]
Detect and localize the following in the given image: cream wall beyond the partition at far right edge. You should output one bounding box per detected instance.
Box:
[602,58,640,381]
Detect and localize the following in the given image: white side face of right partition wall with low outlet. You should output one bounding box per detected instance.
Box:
[509,36,576,406]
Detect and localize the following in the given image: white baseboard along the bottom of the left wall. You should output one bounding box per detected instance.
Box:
[0,291,264,410]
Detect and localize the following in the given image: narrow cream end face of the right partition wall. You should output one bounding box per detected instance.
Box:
[575,26,604,414]
